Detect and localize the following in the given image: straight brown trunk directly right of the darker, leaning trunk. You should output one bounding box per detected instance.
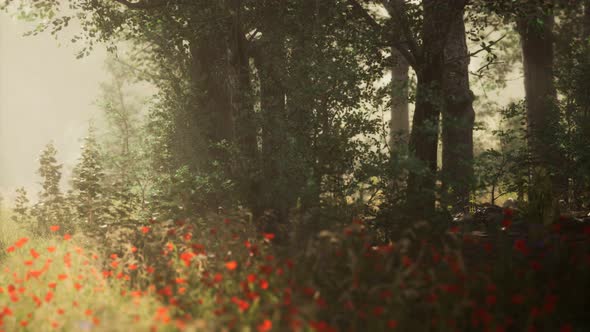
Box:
[442,9,475,210]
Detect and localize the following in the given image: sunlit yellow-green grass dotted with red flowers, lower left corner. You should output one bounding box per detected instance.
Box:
[0,220,171,331]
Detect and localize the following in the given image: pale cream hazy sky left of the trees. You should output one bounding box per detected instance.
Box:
[0,13,108,197]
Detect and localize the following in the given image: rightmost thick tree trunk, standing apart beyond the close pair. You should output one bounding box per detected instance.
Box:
[517,5,567,228]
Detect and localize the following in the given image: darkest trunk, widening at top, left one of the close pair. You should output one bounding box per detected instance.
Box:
[398,0,465,218]
